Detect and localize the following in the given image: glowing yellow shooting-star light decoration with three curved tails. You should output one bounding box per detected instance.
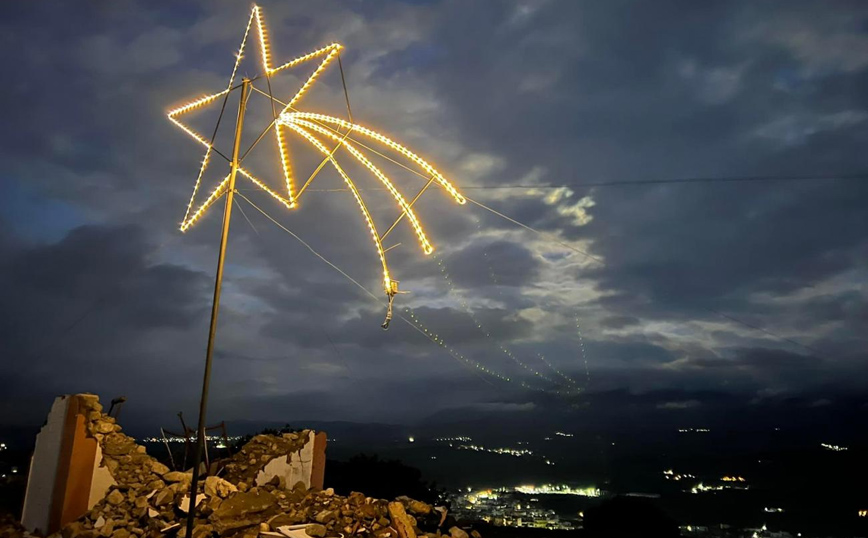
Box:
[168,6,466,298]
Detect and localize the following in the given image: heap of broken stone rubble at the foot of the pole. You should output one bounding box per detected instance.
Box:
[50,396,480,538]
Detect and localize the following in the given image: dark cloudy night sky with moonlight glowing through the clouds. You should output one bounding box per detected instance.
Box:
[0,0,868,425]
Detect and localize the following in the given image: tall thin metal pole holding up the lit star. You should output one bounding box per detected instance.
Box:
[186,79,250,538]
